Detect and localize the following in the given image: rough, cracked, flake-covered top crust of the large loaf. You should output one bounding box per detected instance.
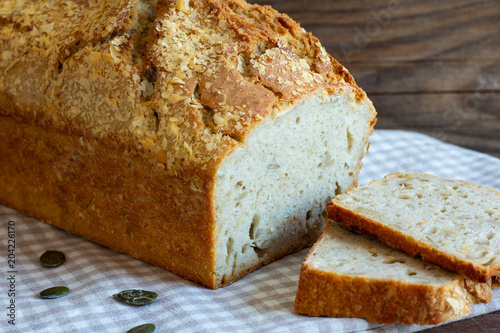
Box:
[0,0,366,175]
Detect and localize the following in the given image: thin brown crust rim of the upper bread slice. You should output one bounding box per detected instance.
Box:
[327,173,500,283]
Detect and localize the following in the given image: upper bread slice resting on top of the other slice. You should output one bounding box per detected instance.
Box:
[328,172,500,282]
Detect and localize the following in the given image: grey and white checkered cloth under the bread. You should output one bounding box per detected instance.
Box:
[0,130,500,333]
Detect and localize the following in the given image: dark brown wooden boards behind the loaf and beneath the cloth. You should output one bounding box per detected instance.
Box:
[250,0,500,333]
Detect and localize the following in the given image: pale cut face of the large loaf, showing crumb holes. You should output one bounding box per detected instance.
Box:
[214,93,373,285]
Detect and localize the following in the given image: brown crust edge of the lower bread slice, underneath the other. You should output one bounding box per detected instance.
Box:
[295,220,492,325]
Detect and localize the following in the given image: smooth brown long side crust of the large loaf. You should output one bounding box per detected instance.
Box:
[0,117,223,288]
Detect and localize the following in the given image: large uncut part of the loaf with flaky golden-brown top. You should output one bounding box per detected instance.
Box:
[0,0,375,288]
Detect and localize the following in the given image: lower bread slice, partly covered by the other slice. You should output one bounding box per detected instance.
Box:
[295,220,492,325]
